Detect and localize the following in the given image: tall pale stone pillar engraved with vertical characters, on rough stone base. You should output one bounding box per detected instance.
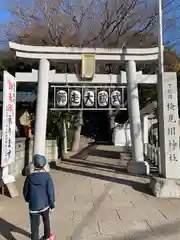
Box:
[150,73,180,198]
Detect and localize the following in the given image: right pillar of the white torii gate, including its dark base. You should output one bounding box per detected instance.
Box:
[126,60,150,175]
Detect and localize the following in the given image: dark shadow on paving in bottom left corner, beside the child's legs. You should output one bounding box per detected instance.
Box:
[0,217,30,240]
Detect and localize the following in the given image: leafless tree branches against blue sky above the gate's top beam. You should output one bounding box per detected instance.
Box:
[3,0,180,47]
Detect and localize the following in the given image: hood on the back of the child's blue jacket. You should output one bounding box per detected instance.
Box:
[28,172,49,186]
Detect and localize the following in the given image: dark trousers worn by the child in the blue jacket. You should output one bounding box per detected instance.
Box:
[30,209,50,240]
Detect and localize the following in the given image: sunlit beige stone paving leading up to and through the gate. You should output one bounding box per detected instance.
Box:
[0,145,180,240]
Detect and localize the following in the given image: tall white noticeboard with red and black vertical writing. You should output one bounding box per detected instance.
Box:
[1,71,16,167]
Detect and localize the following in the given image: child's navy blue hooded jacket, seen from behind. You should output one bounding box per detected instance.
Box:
[23,172,55,211]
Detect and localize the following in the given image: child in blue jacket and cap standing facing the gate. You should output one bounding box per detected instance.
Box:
[23,154,55,240]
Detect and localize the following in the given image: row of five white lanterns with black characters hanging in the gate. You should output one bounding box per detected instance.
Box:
[53,85,127,110]
